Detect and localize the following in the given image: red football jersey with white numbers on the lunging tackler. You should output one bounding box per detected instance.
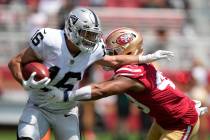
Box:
[115,64,198,130]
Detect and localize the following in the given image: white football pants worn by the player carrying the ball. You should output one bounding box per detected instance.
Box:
[18,103,80,140]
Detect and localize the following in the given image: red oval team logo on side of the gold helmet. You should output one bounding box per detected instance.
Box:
[116,33,134,45]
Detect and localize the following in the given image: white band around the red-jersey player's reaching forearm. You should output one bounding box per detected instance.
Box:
[68,86,91,101]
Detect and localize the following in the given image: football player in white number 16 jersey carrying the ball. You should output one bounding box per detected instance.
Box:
[8,7,173,140]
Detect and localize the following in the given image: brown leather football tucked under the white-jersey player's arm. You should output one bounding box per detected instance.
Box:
[22,62,49,81]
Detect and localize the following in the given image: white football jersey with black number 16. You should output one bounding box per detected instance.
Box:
[29,28,105,112]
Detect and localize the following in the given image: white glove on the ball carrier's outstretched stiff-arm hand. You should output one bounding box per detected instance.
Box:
[139,50,174,63]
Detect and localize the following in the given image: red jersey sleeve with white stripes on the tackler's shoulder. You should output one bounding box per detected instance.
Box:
[115,65,145,79]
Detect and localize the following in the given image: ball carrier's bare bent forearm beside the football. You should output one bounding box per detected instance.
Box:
[8,58,23,84]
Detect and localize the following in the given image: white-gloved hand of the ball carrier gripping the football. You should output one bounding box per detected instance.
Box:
[22,72,51,90]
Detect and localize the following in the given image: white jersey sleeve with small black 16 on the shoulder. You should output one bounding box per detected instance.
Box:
[29,28,49,60]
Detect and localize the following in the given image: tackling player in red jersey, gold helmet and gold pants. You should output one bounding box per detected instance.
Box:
[45,28,207,140]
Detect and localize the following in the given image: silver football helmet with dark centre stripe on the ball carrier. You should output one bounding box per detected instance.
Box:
[64,7,102,52]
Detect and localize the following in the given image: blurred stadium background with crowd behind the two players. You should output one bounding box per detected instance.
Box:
[0,0,210,140]
